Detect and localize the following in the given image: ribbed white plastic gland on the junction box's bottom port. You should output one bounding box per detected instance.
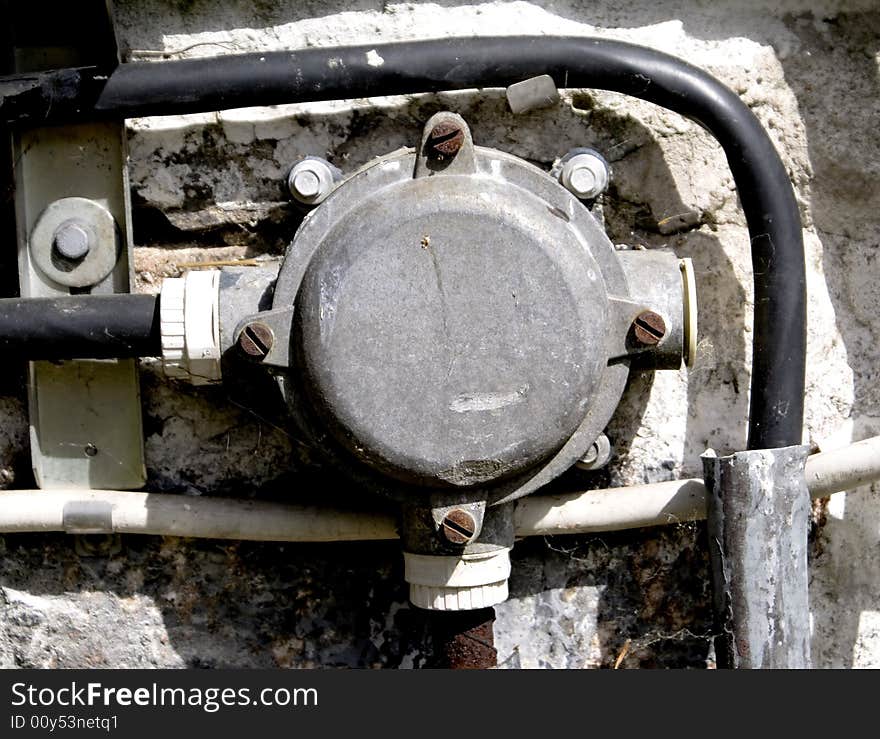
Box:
[403,549,510,611]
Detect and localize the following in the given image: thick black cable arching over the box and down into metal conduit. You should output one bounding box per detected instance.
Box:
[96,36,806,449]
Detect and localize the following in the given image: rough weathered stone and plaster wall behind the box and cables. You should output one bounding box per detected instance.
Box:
[0,0,880,667]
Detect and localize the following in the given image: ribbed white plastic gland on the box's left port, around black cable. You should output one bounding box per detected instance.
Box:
[159,269,221,385]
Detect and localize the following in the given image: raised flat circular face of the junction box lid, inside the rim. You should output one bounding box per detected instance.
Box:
[292,175,607,486]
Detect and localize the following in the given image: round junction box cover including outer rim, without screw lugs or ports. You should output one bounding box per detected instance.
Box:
[272,115,648,502]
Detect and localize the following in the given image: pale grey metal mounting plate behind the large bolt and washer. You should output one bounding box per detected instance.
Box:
[12,121,146,489]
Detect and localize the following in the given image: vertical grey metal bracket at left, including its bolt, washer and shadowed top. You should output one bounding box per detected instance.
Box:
[8,3,146,500]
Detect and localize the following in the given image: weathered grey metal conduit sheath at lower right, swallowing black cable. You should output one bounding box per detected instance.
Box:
[703,446,811,669]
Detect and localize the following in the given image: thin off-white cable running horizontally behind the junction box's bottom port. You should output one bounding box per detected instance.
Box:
[0,437,880,542]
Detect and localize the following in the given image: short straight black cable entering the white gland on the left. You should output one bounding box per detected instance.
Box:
[0,294,162,359]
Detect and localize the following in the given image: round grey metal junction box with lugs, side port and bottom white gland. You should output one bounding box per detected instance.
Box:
[227,113,696,610]
